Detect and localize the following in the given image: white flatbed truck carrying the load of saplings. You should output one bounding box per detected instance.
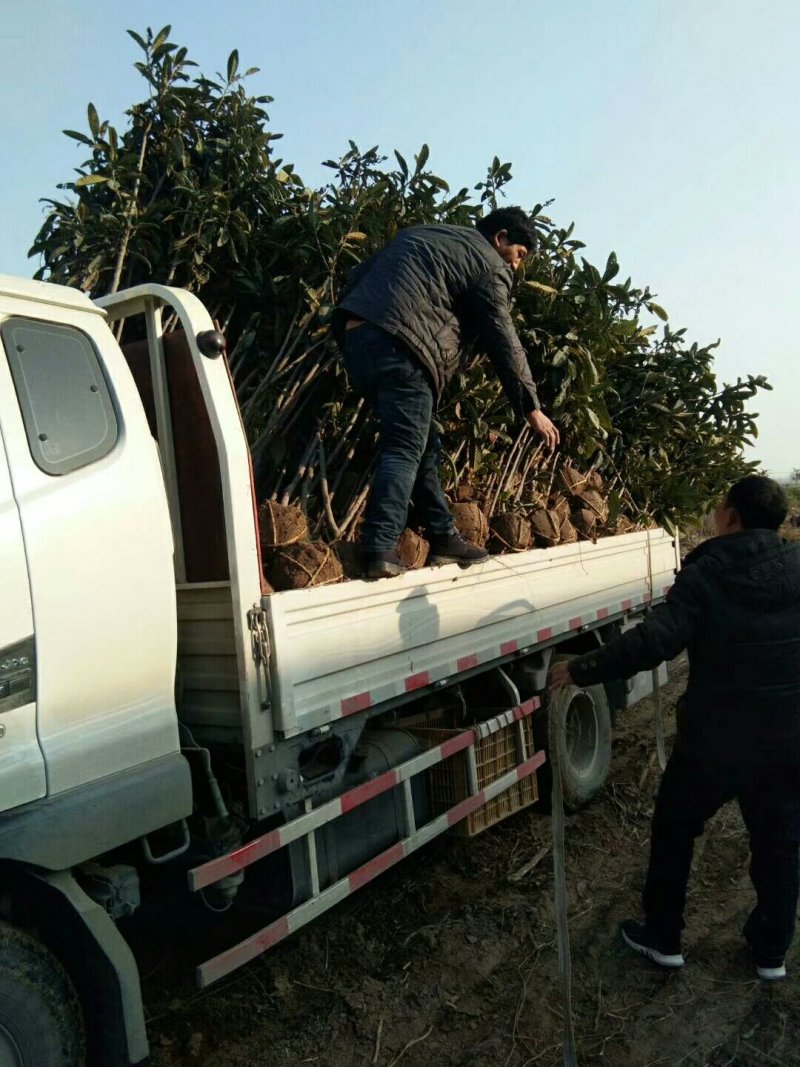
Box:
[0,275,678,1067]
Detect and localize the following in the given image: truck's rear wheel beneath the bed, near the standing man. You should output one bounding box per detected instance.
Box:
[533,656,611,811]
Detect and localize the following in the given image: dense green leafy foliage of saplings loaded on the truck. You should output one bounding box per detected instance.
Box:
[31,26,769,537]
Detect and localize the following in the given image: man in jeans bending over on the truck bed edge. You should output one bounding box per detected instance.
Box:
[334,207,559,578]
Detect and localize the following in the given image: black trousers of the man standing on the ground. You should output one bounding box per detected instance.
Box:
[643,752,800,961]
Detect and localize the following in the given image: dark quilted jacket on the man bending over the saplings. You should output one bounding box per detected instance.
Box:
[334,226,539,417]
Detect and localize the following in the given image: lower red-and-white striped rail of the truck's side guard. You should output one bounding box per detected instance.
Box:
[196,752,544,989]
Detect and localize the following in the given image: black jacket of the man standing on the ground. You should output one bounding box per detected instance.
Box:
[570,530,800,764]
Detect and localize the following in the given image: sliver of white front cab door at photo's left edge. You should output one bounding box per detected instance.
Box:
[0,416,47,811]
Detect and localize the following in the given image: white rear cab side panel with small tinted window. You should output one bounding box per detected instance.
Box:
[0,296,179,802]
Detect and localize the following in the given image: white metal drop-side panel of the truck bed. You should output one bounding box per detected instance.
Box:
[261,529,679,737]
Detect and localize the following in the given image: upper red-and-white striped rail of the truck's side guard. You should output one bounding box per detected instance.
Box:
[188,697,540,891]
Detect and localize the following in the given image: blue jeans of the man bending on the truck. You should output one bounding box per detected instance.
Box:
[343,322,455,555]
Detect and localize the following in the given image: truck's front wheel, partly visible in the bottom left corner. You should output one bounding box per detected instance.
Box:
[0,922,84,1067]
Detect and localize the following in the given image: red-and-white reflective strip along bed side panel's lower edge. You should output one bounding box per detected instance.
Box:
[330,586,672,720]
